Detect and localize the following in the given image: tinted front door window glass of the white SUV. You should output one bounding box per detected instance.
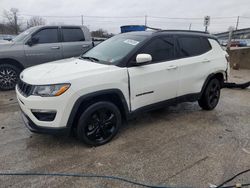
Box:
[140,37,175,62]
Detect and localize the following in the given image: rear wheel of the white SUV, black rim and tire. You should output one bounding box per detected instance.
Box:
[198,78,221,110]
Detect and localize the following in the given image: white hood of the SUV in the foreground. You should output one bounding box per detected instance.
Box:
[20,58,116,85]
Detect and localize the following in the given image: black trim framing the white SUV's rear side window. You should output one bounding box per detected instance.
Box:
[175,35,212,59]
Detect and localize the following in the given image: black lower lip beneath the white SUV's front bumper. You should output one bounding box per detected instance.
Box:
[22,111,70,135]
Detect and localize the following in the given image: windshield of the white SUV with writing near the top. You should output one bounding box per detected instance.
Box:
[82,34,147,65]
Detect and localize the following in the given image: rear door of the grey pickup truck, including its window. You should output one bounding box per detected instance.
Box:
[61,27,92,58]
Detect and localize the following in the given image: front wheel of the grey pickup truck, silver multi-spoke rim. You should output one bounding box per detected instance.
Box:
[0,64,21,91]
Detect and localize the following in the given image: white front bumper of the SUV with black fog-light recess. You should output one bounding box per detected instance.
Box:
[16,84,75,133]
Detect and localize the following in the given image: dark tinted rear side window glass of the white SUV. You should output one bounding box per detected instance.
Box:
[178,37,211,57]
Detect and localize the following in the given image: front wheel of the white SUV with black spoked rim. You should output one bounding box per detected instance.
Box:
[77,101,122,146]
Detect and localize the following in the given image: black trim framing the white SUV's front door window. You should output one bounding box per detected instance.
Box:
[127,34,178,67]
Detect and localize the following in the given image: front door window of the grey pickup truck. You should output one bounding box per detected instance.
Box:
[33,28,58,44]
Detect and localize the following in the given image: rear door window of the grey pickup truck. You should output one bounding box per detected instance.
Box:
[62,28,85,42]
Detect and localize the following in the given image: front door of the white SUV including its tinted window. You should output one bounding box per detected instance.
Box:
[128,36,179,110]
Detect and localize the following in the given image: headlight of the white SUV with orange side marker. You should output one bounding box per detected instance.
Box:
[32,84,70,97]
